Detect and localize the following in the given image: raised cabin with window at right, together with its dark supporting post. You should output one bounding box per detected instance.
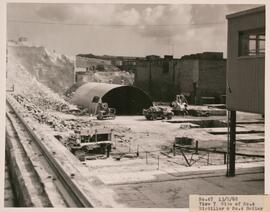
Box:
[226,7,265,176]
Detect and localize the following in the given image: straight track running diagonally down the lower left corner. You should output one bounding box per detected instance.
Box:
[6,97,94,207]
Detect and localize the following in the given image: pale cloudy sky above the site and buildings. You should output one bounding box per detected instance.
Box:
[7,3,259,58]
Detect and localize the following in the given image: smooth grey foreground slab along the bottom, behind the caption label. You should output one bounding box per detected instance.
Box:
[110,167,264,208]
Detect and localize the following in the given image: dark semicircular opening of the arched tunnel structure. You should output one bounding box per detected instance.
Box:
[102,86,153,115]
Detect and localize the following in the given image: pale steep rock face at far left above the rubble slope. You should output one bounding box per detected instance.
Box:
[8,45,74,94]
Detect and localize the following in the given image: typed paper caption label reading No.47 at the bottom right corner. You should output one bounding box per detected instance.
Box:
[189,195,270,212]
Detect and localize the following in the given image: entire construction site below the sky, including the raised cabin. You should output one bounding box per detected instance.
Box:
[5,3,265,208]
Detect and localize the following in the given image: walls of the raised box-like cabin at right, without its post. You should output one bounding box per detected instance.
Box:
[227,7,265,114]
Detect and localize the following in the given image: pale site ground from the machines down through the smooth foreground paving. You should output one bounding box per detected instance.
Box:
[10,97,264,208]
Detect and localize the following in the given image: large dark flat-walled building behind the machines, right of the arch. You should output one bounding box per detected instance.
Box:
[134,52,226,104]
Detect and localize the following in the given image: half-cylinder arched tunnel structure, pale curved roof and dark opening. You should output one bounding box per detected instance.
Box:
[71,82,153,115]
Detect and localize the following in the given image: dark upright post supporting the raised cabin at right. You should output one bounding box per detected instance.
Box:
[227,111,236,177]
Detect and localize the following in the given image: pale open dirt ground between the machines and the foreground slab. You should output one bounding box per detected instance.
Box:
[46,112,264,178]
